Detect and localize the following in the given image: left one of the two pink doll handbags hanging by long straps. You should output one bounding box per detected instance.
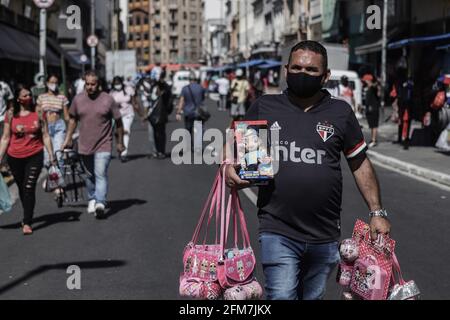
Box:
[179,172,223,300]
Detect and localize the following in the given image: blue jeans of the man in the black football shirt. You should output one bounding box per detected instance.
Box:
[259,232,340,300]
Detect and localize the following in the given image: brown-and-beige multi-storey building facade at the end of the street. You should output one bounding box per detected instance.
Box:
[128,0,204,68]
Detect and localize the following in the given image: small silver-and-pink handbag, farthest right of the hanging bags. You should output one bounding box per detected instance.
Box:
[387,254,420,300]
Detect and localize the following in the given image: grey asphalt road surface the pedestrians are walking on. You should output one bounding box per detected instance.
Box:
[0,95,450,299]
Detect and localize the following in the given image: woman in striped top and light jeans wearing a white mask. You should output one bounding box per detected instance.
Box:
[36,74,69,206]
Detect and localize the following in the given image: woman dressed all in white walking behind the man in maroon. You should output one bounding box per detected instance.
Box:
[109,77,137,163]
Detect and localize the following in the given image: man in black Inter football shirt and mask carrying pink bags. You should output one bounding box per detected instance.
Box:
[225,41,390,300]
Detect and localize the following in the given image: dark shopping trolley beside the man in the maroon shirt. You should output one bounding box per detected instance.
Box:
[55,149,86,207]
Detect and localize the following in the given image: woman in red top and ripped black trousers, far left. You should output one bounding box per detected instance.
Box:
[0,88,55,235]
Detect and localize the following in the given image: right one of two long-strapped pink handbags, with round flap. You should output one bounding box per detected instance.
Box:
[217,185,256,289]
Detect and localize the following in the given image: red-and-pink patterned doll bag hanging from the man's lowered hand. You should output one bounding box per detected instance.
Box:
[350,220,395,300]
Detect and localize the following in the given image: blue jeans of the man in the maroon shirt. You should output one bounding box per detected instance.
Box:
[81,152,111,205]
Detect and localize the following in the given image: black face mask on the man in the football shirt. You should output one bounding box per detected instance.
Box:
[286,72,324,98]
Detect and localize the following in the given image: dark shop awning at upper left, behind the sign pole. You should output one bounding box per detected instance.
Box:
[0,24,60,66]
